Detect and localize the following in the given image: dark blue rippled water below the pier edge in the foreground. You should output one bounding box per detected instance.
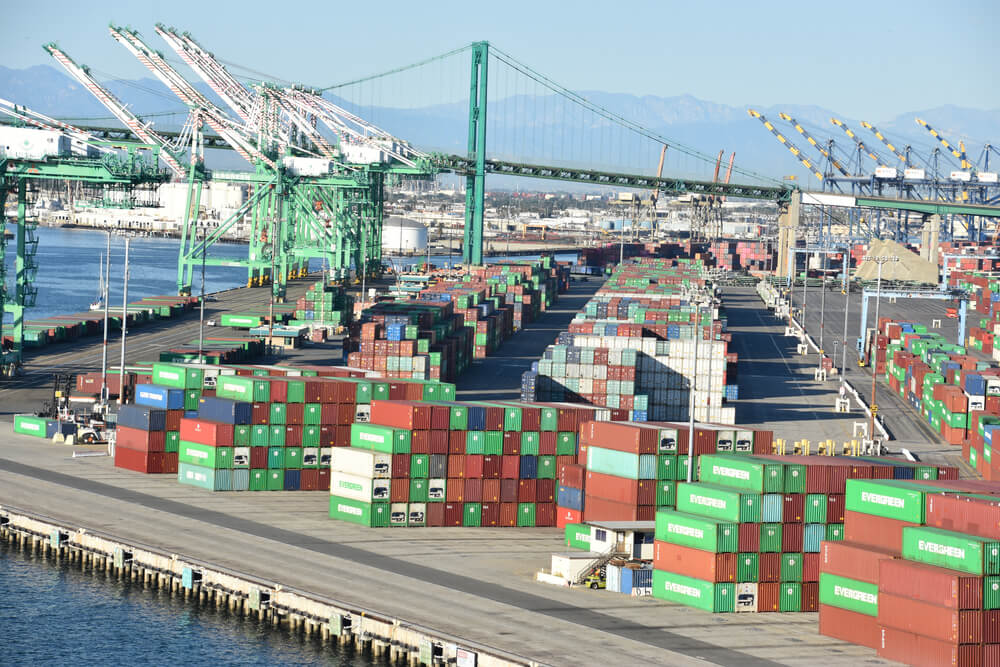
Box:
[0,543,376,667]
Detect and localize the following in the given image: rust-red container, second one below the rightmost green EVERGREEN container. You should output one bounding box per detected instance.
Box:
[878,584,983,644]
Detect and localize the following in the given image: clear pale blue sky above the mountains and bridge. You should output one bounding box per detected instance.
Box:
[0,0,1000,120]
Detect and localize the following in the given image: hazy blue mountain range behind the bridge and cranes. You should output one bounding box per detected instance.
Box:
[0,65,1000,182]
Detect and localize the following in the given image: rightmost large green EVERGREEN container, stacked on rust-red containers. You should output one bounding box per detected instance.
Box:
[903,526,1000,575]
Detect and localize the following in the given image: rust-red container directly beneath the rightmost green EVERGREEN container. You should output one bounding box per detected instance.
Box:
[878,559,983,612]
